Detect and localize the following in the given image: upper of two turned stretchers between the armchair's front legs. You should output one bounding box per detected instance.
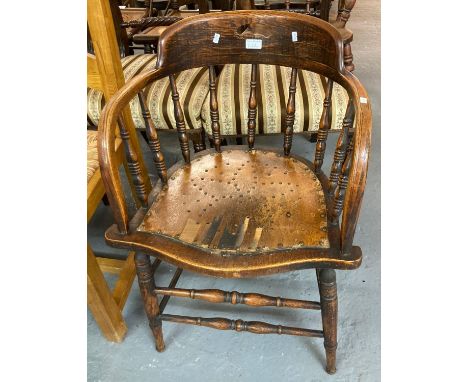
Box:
[154,286,320,310]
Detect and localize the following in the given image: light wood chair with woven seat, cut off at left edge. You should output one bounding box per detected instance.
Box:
[87,0,150,342]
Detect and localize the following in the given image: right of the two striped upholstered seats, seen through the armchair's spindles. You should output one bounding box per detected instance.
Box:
[201,64,348,135]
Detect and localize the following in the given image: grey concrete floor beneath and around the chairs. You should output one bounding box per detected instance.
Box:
[88,0,380,382]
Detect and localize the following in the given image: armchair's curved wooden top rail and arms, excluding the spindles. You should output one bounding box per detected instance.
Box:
[98,11,372,255]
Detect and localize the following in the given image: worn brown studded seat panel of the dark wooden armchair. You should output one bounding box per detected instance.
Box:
[137,149,330,253]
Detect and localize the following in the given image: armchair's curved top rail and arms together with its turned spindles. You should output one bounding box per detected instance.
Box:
[98,11,371,255]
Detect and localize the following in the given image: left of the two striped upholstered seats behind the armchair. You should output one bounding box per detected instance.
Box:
[87,54,209,129]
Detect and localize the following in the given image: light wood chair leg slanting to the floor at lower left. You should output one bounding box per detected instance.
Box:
[87,244,127,342]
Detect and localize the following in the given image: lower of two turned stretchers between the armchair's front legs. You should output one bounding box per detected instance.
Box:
[159,314,323,338]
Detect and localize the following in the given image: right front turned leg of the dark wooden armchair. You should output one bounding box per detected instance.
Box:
[317,269,338,374]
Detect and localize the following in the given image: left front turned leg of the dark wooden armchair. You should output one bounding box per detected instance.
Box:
[135,253,165,352]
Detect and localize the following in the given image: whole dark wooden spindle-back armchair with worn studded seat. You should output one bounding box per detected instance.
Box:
[98,11,371,373]
